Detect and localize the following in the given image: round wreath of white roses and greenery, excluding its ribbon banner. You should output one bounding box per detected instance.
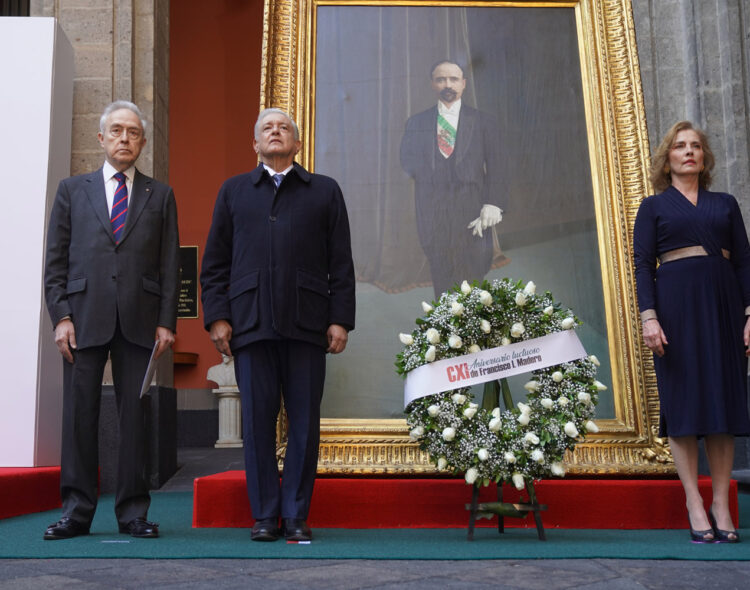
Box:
[396,279,606,489]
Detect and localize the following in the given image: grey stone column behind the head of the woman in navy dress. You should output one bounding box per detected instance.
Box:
[632,0,750,210]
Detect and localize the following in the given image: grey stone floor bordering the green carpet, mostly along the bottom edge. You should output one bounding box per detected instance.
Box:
[0,449,750,590]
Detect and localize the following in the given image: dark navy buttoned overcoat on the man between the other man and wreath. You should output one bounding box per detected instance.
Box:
[201,164,355,350]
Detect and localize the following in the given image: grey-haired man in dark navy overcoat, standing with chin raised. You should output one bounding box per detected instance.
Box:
[201,109,355,541]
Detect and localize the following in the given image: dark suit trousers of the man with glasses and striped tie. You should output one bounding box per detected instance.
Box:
[60,325,151,525]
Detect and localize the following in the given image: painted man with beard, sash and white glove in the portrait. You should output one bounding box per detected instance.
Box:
[401,60,502,298]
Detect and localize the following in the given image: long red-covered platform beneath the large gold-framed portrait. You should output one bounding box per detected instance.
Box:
[193,471,737,529]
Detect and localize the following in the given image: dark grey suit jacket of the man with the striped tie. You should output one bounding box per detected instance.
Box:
[45,168,179,349]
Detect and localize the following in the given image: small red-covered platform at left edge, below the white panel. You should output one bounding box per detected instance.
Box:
[0,467,60,518]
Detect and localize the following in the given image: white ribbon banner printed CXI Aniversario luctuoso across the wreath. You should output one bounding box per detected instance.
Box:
[404,330,586,407]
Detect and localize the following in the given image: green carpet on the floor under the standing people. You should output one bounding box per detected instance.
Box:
[0,492,750,560]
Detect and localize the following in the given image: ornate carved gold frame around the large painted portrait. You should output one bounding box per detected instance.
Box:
[261,0,673,475]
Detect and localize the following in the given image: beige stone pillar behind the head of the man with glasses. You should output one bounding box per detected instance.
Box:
[31,0,169,182]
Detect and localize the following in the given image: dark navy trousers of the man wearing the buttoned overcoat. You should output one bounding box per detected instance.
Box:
[234,340,326,519]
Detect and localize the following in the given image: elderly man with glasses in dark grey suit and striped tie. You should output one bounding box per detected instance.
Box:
[44,101,179,540]
